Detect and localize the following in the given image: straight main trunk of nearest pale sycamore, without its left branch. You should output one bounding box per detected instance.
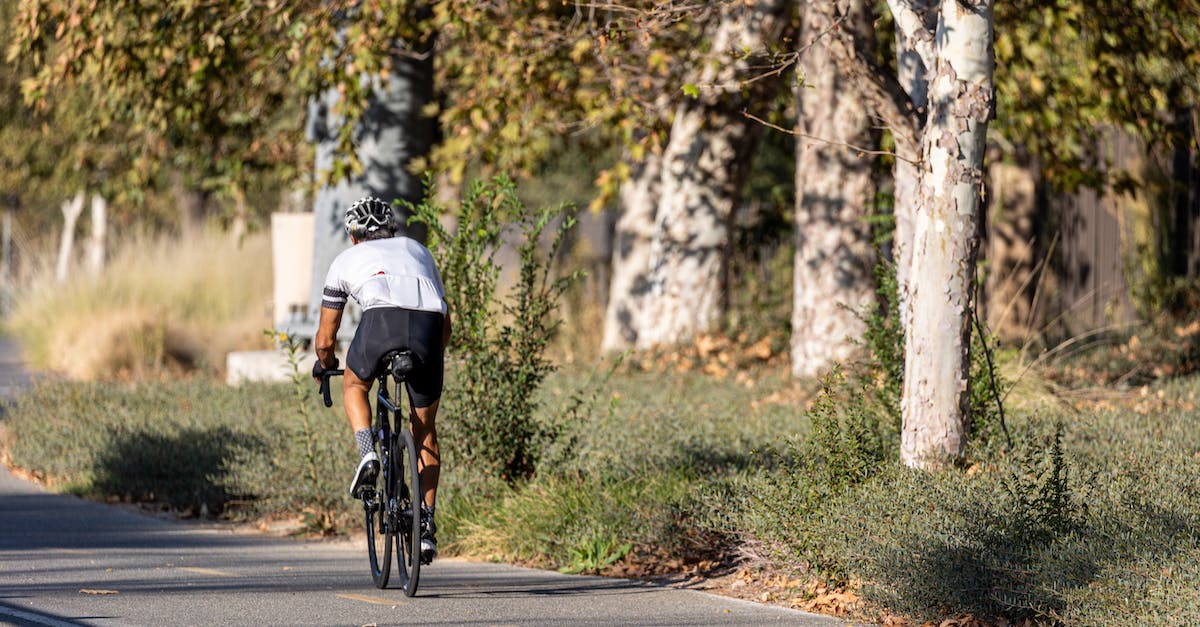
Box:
[898,0,994,468]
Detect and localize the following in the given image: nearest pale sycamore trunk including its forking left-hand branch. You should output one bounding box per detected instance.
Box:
[806,0,995,468]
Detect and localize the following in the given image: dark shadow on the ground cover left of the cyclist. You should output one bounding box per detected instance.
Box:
[94,426,264,514]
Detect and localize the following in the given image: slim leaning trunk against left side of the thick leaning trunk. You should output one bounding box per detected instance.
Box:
[600,151,662,352]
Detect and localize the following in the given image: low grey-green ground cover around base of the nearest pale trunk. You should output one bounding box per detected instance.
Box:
[732,380,1200,625]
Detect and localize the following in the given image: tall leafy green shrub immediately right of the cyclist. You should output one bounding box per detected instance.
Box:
[413,178,576,483]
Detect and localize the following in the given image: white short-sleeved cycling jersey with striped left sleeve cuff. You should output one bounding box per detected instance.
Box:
[320,237,446,315]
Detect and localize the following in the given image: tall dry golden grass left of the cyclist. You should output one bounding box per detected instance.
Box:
[7,232,271,381]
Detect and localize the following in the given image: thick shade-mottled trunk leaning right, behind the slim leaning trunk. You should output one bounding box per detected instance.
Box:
[634,0,792,348]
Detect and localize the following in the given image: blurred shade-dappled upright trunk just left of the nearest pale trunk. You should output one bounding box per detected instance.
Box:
[792,0,875,376]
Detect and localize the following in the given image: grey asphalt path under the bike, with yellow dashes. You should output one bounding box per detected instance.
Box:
[0,340,844,626]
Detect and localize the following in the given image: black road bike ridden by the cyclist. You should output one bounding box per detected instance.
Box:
[320,351,422,597]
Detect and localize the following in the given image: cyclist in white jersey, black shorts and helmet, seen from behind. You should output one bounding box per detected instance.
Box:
[312,196,450,563]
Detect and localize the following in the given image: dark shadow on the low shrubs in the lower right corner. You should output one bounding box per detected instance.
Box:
[868,490,1200,623]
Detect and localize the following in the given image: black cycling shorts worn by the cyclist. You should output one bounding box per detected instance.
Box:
[346,307,445,407]
